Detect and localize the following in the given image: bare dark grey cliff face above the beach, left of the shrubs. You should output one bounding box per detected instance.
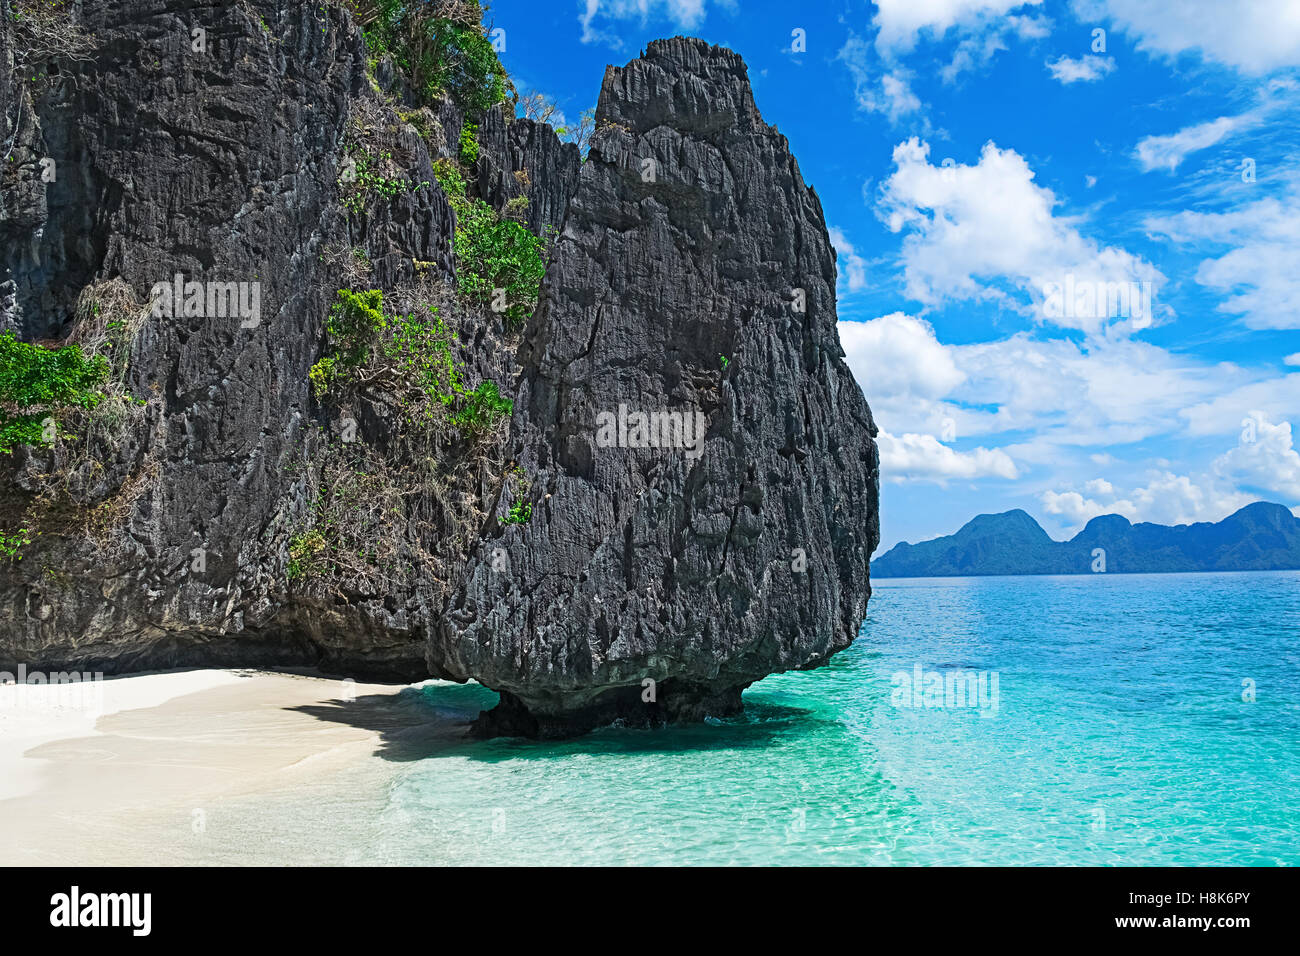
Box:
[0,0,452,678]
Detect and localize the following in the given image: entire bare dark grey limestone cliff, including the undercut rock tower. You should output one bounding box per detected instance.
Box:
[0,0,878,736]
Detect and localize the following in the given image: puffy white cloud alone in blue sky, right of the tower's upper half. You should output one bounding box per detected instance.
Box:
[878,138,1165,334]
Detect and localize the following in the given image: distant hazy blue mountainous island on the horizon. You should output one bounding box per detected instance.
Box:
[871,501,1300,578]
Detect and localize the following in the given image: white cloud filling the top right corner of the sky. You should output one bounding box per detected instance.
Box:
[1074,0,1300,74]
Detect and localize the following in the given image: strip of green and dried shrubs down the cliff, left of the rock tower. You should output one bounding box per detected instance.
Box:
[299,0,533,596]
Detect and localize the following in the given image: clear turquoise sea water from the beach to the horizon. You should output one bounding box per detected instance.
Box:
[369,571,1300,865]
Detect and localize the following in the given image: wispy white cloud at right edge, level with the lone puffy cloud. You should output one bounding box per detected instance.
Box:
[1145,186,1300,329]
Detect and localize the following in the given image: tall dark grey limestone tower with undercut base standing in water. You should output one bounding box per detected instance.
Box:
[439,38,878,735]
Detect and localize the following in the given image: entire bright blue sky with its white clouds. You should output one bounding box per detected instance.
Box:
[489,0,1300,550]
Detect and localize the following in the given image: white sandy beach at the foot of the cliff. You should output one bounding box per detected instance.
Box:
[0,670,452,865]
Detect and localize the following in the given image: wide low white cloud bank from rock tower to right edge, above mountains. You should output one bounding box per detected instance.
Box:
[840,312,1300,520]
